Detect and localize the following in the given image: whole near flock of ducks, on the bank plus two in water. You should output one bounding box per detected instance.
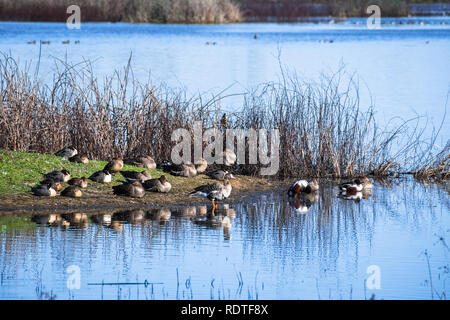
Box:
[32,146,373,210]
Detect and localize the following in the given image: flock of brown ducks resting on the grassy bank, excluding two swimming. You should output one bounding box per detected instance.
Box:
[32,146,236,209]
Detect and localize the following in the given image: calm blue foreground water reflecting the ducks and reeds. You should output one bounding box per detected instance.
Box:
[0,180,450,299]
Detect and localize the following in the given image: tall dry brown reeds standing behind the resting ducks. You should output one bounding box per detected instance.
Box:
[0,56,450,179]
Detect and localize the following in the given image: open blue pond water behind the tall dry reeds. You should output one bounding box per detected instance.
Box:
[0,17,450,141]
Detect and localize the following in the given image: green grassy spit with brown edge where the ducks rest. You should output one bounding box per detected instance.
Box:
[0,150,273,210]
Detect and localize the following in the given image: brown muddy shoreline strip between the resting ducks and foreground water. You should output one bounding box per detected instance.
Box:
[0,177,288,215]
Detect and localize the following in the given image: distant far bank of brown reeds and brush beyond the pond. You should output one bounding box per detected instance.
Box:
[0,0,449,23]
